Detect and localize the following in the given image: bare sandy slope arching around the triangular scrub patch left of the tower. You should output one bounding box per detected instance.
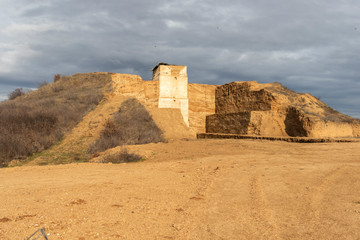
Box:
[17,73,200,164]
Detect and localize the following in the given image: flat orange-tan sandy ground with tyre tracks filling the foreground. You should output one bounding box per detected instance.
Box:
[0,139,360,240]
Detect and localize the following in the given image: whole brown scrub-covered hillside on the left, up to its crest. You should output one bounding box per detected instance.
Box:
[0,75,108,166]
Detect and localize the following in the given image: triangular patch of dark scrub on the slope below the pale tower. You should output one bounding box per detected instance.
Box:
[89,99,164,153]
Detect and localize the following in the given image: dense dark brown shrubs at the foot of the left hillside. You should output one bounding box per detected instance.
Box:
[0,101,81,165]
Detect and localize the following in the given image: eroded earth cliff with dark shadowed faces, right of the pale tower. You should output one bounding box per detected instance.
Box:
[206,81,359,137]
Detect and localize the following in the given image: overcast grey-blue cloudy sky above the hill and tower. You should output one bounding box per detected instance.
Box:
[0,0,360,118]
